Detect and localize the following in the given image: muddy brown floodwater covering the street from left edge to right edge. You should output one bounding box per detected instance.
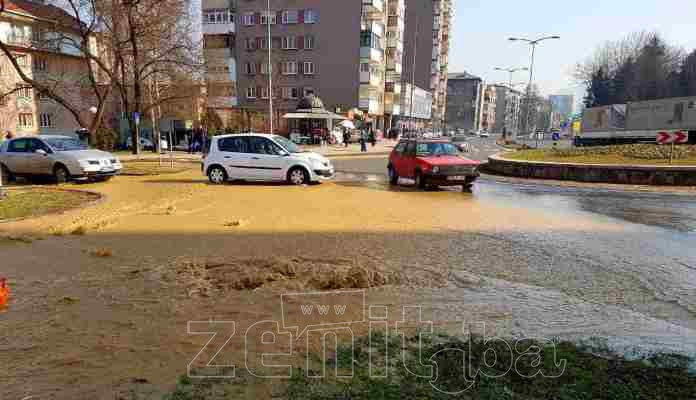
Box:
[0,143,696,399]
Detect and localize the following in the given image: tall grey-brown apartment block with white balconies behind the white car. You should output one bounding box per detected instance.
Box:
[202,0,452,132]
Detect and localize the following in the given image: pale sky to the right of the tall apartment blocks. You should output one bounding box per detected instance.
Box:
[449,0,696,101]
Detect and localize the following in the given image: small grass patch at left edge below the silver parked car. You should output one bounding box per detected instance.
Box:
[0,188,97,220]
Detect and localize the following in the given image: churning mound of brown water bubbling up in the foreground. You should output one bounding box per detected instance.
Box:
[169,258,400,297]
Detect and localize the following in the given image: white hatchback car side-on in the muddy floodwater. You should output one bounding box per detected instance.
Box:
[203,133,334,185]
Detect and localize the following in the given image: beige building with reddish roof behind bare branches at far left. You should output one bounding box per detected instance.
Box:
[0,0,95,136]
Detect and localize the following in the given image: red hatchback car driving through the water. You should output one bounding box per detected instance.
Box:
[387,139,480,190]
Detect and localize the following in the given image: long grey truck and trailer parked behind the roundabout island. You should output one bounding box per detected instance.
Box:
[575,97,696,146]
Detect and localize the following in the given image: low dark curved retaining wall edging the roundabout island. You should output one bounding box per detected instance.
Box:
[486,154,696,186]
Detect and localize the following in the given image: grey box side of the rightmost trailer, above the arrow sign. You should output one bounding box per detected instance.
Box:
[627,97,696,130]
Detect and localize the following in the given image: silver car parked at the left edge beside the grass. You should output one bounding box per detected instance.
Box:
[0,135,122,183]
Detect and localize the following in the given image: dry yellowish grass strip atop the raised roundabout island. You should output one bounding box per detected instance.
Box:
[505,144,696,165]
